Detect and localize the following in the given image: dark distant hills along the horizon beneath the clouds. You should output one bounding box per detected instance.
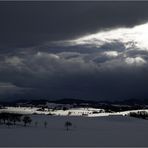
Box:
[0,98,148,107]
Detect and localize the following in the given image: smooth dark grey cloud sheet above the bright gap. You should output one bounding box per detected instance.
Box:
[0,1,148,50]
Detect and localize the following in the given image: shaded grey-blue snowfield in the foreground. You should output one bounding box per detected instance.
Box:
[0,115,148,147]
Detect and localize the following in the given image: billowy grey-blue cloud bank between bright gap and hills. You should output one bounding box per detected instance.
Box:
[0,44,148,99]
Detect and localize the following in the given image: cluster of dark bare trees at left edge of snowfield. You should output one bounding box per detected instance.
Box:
[0,113,32,126]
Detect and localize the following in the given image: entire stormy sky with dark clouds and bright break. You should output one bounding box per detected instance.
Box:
[0,1,148,100]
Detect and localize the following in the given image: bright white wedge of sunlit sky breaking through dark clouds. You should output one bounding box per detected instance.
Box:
[67,23,148,51]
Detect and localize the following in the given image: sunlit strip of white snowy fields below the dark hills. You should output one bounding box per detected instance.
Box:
[0,107,148,117]
